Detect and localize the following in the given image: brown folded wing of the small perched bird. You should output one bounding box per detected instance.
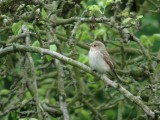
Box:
[101,50,114,69]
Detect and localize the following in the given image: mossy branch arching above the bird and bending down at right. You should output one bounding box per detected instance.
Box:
[52,17,149,59]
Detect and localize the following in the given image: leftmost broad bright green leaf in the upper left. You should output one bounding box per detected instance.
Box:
[12,21,22,35]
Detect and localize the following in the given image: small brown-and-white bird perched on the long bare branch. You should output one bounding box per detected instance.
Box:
[88,41,121,81]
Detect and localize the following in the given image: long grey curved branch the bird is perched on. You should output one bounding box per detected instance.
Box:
[0,44,155,118]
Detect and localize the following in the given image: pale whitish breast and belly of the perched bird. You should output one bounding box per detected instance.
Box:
[89,50,110,73]
